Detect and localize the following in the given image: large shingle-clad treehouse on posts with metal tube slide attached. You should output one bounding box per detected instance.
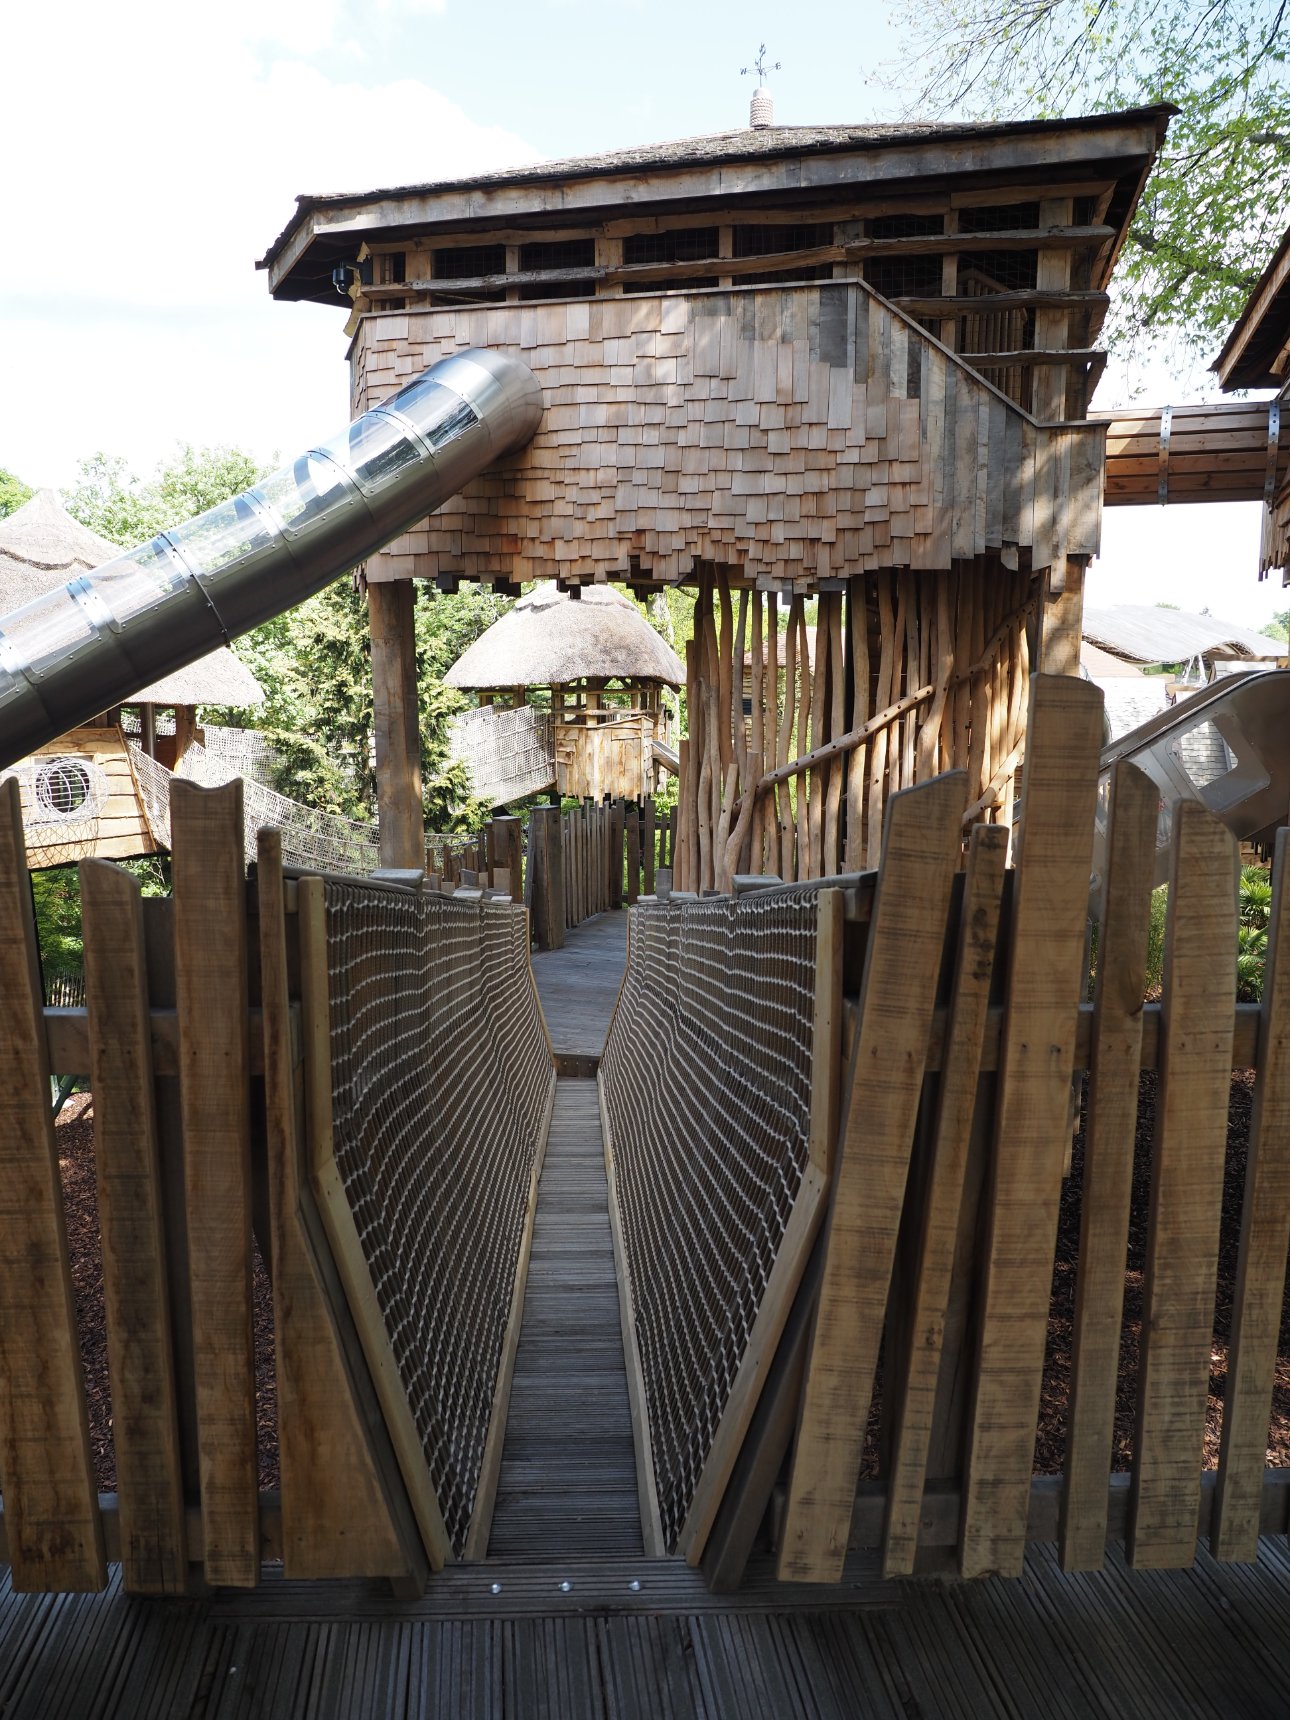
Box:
[261,101,1171,873]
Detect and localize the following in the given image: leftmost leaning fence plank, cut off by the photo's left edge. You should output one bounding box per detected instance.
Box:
[0,777,107,1593]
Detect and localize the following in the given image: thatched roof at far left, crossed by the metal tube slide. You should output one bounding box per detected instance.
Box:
[0,490,265,707]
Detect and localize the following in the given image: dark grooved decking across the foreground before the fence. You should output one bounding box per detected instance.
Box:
[0,1538,1290,1720]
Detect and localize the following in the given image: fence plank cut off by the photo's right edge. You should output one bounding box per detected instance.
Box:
[1209,829,1290,1560]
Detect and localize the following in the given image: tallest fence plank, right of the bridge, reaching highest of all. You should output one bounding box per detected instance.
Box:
[960,674,1103,1576]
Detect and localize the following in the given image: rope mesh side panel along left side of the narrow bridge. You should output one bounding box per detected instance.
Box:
[325,879,554,1553]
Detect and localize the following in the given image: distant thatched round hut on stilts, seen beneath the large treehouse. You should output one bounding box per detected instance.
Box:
[444,583,685,805]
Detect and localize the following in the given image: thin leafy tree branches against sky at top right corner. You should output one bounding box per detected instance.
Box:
[901,0,1290,358]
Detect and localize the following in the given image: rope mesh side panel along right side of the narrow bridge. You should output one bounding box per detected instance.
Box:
[600,893,819,1548]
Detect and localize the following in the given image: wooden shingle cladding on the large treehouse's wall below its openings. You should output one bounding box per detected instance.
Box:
[353,282,1106,592]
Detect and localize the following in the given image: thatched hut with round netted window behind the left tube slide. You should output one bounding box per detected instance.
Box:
[0,490,265,867]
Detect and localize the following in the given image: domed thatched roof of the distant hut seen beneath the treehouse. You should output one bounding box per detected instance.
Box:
[444,580,685,688]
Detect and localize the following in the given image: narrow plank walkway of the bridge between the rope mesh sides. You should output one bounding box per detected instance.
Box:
[488,1080,642,1572]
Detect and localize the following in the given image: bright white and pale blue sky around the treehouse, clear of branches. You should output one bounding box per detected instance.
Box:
[0,0,1283,626]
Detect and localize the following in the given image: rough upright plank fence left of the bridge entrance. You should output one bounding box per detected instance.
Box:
[0,781,549,1594]
